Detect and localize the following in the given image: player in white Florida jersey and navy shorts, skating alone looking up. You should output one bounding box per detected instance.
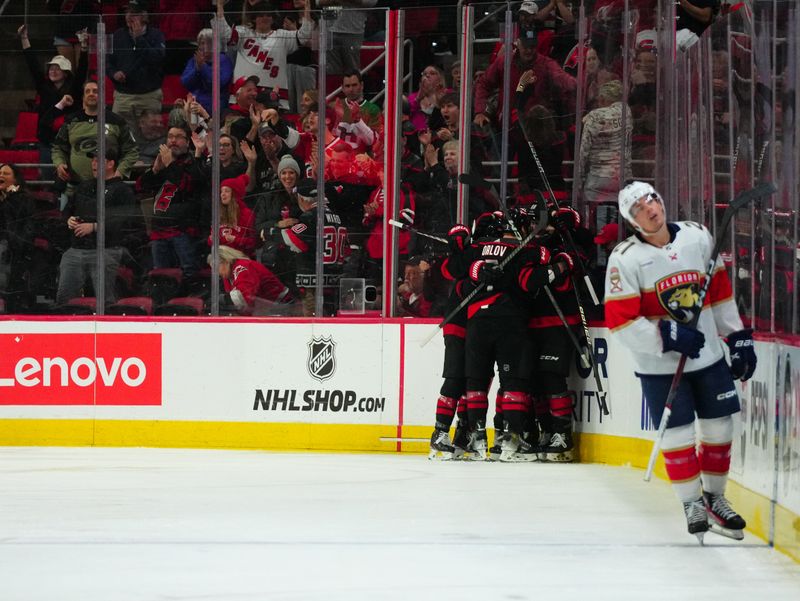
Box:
[605,181,756,542]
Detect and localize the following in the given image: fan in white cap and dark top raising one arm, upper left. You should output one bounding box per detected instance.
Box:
[17,25,89,155]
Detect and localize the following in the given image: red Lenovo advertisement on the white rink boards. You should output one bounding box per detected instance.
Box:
[0,334,161,405]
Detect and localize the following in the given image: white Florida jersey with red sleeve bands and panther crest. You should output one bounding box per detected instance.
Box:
[605,221,744,374]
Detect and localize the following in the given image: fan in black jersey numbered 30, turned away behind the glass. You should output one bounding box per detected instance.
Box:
[275,178,350,317]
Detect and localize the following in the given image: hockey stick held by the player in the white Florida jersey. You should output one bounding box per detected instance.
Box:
[644,183,777,482]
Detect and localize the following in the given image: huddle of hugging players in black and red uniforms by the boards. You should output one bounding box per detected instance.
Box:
[430,198,580,462]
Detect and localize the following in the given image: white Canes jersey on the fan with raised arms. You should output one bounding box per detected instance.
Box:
[218,19,313,109]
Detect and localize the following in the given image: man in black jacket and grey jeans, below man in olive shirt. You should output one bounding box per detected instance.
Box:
[56,140,145,305]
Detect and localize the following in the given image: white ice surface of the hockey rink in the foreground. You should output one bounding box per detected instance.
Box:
[0,447,800,601]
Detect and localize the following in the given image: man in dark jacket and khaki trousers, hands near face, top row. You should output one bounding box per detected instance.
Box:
[106,1,166,134]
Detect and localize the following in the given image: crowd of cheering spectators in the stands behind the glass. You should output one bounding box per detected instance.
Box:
[0,0,668,316]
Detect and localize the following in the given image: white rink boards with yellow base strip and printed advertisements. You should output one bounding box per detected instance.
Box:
[0,318,800,559]
